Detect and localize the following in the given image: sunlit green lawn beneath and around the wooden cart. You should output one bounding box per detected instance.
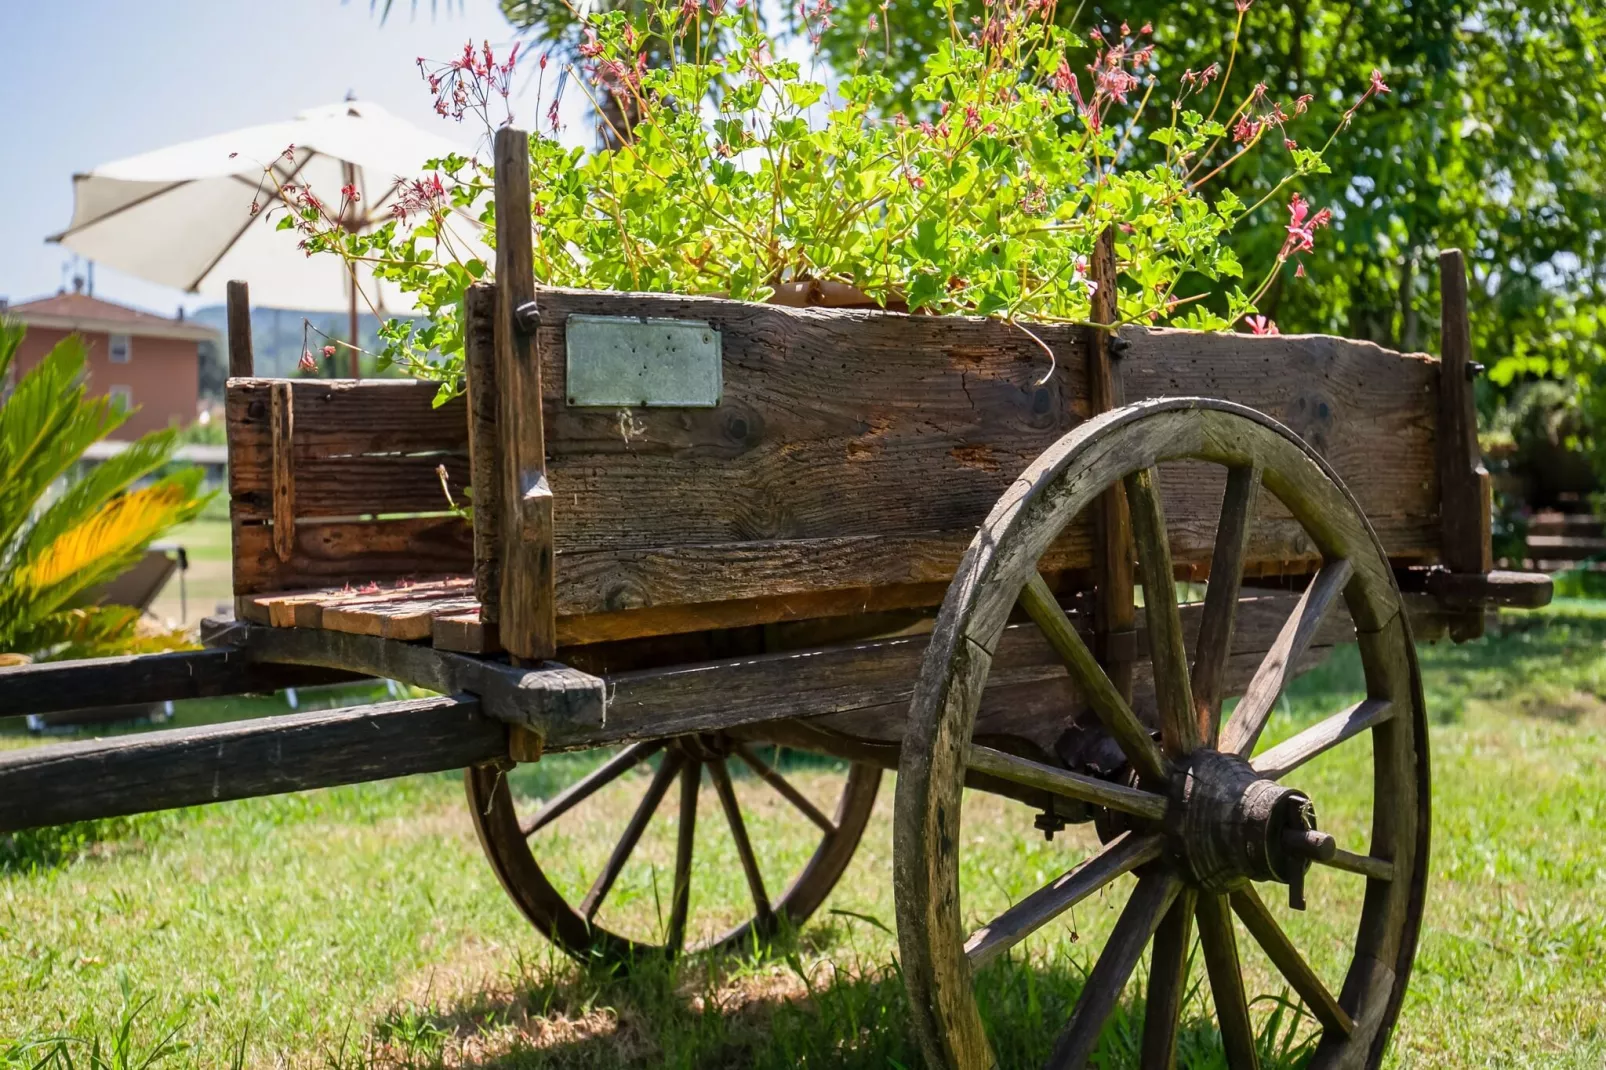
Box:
[0,604,1606,1068]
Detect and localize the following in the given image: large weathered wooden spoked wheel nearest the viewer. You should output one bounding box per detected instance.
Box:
[893,398,1428,1070]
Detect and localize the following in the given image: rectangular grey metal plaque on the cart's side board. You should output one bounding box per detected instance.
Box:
[565,315,724,408]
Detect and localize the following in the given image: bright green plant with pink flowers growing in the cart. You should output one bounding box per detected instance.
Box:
[281,0,1388,397]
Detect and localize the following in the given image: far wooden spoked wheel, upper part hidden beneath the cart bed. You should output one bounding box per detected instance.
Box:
[466,734,882,966]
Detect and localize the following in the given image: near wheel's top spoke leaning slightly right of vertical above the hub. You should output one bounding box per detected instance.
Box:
[1190,466,1261,747]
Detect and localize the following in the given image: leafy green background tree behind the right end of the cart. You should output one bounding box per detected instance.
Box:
[824,0,1606,379]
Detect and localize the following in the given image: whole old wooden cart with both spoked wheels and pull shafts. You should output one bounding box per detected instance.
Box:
[0,132,1550,1070]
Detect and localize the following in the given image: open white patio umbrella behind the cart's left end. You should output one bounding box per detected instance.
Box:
[50,100,485,374]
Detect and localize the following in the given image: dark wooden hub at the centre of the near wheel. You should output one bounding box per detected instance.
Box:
[1168,750,1315,893]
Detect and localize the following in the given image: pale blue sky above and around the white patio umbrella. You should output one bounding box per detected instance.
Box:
[0,0,588,315]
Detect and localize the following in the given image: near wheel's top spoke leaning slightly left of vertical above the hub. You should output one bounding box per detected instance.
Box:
[1126,468,1200,757]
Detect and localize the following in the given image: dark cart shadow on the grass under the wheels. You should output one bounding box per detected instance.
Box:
[351,925,1314,1070]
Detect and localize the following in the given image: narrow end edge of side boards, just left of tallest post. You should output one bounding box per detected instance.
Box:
[463,283,503,623]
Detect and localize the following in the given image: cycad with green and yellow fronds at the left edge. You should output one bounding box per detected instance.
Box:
[0,323,206,659]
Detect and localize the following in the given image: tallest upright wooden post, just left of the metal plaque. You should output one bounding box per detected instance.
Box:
[495,127,557,660]
